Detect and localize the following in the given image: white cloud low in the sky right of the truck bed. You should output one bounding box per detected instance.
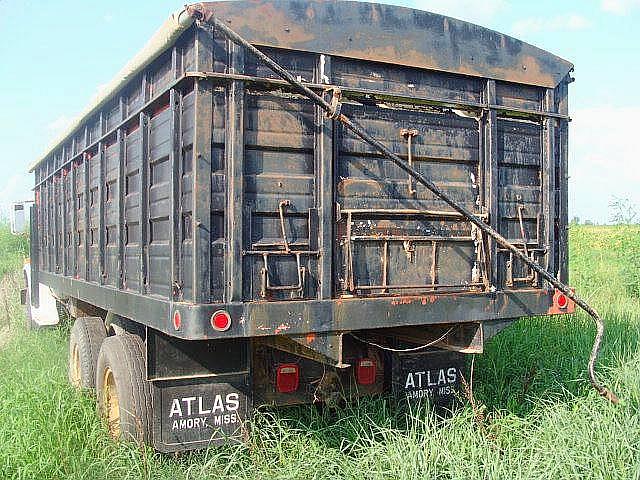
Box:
[569,106,640,223]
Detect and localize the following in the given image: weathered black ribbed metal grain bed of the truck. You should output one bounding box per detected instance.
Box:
[28,1,572,354]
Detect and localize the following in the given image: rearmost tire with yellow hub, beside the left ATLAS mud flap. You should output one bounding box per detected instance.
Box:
[96,334,152,445]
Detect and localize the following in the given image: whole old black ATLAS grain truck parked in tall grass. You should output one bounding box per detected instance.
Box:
[24,0,577,452]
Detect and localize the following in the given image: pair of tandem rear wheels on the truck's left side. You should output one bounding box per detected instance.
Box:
[69,317,152,444]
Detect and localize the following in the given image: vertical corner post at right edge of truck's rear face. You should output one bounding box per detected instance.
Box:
[538,88,557,282]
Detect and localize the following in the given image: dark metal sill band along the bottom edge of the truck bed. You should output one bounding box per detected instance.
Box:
[41,272,571,340]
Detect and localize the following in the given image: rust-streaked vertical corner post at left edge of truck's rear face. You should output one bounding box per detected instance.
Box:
[192,29,213,303]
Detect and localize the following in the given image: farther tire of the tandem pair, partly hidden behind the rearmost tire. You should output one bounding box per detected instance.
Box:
[69,317,107,392]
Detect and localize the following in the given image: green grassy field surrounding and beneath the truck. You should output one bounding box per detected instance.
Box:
[0,226,640,480]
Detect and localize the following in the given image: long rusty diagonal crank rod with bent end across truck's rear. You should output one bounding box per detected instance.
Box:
[194,15,618,403]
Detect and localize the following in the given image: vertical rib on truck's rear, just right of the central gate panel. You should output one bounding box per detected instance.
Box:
[482,80,500,287]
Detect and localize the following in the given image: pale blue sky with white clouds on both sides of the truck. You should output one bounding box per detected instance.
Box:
[0,0,640,223]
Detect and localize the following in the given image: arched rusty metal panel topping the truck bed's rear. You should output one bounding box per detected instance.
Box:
[191,0,573,88]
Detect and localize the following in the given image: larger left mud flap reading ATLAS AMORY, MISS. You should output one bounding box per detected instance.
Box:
[153,374,253,452]
